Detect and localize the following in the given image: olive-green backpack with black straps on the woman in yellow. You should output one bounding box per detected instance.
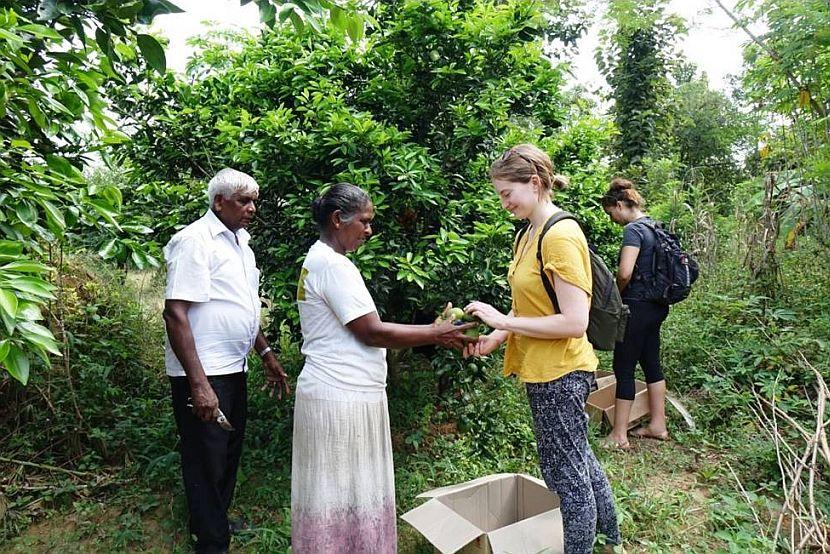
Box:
[514,211,628,350]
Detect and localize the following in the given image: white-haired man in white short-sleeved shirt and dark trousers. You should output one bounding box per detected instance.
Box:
[164,169,290,553]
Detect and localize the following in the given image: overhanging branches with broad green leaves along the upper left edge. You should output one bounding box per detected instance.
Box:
[0,0,188,383]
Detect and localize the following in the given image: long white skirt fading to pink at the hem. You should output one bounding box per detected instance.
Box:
[291,374,397,554]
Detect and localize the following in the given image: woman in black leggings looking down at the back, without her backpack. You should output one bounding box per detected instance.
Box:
[600,178,691,448]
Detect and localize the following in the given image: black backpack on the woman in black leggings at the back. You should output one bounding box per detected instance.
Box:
[637,221,700,305]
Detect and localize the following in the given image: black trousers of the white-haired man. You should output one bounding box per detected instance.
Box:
[170,372,248,554]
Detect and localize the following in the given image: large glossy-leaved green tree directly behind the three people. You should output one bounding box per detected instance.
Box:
[112,0,613,332]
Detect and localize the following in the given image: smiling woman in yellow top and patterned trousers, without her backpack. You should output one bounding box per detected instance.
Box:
[465,144,620,554]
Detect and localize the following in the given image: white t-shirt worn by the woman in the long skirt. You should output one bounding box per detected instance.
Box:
[297,240,386,392]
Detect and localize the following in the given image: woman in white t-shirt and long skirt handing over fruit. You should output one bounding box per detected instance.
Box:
[291,183,471,554]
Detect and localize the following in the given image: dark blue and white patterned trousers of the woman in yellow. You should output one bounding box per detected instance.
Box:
[526,371,620,554]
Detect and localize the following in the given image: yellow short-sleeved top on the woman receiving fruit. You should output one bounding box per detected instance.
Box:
[504,213,599,383]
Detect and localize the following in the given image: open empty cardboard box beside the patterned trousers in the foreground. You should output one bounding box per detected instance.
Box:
[401,473,565,554]
